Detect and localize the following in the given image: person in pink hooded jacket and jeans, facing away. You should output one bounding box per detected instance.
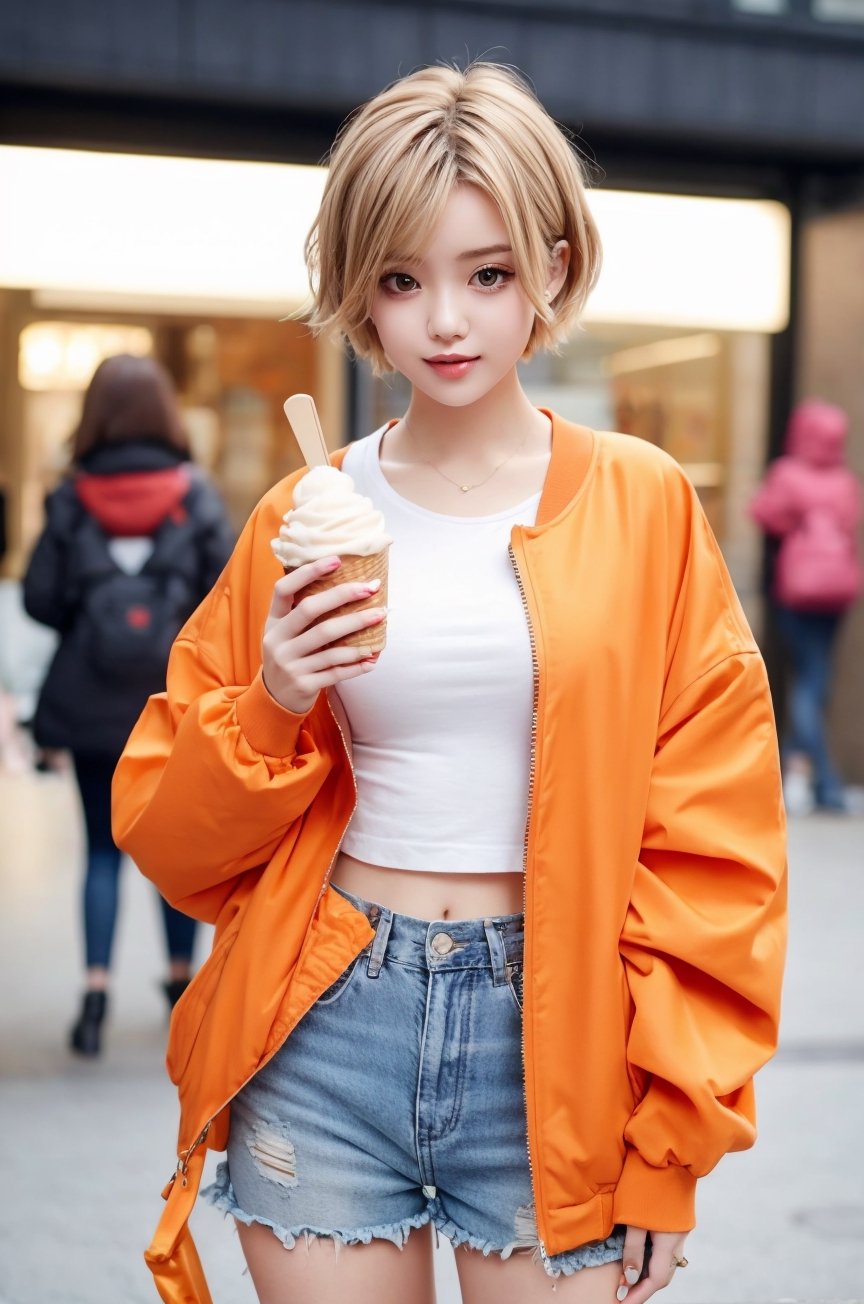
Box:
[751,399,864,815]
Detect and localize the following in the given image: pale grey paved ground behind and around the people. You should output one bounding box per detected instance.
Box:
[0,776,864,1304]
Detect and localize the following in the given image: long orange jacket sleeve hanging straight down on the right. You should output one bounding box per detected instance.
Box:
[615,492,786,1231]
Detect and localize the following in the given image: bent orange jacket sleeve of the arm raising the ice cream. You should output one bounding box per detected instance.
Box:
[115,485,331,922]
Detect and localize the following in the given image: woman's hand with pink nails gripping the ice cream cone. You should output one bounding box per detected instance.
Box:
[263,557,387,716]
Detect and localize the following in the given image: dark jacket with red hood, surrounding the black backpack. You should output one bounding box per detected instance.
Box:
[23,439,233,758]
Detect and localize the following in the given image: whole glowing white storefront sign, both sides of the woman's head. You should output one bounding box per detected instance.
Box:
[0,147,790,331]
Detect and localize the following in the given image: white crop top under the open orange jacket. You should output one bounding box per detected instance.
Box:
[339,430,540,874]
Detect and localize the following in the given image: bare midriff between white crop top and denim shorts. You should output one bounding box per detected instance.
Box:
[330,852,523,919]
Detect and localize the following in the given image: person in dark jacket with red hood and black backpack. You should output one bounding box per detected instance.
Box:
[23,355,233,1056]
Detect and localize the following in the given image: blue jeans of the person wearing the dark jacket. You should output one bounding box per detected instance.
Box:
[72,752,195,969]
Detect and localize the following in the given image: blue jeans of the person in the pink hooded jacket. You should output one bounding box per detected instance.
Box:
[777,606,844,807]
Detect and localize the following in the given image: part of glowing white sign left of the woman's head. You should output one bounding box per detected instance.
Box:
[0,146,324,316]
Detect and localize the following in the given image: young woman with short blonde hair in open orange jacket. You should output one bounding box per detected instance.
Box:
[115,64,785,1304]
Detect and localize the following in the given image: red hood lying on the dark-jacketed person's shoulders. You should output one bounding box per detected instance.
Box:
[76,466,189,539]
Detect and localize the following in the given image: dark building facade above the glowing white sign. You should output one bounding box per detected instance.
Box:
[0,0,864,178]
